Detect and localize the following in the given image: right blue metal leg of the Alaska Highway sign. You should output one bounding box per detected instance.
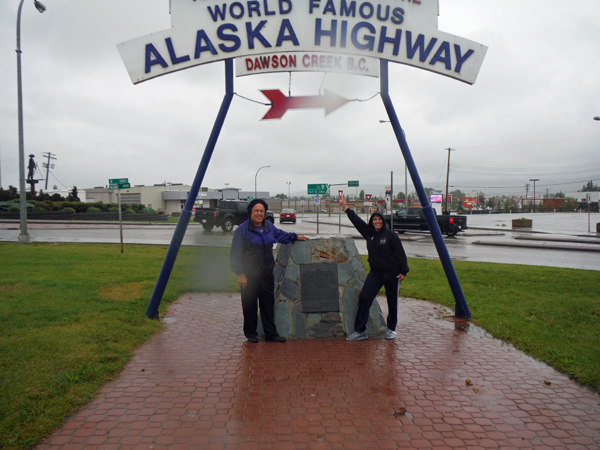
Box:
[380,59,471,318]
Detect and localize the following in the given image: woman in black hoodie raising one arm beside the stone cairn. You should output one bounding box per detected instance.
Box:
[340,198,409,341]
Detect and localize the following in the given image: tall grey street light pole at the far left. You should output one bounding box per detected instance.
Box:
[17,0,46,244]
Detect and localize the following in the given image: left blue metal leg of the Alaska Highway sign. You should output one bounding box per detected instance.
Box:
[146,59,233,319]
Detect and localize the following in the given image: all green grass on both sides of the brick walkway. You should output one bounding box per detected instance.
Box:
[0,243,600,449]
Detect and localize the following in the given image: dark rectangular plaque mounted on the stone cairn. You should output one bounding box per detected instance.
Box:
[300,263,340,313]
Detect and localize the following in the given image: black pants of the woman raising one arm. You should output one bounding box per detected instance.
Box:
[354,271,400,333]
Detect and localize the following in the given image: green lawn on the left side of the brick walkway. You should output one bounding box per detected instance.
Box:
[0,244,237,449]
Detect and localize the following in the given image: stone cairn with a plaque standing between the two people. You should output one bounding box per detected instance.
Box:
[259,236,387,339]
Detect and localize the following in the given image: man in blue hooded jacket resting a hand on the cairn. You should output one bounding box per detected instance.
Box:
[229,199,308,343]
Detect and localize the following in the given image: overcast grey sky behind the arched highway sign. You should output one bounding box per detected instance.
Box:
[0,0,600,200]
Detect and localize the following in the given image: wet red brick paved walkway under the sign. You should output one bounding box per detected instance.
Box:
[38,294,600,450]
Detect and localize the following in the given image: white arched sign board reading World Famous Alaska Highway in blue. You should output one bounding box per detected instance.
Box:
[118,0,487,84]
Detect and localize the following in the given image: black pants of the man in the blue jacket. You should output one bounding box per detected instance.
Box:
[242,273,278,339]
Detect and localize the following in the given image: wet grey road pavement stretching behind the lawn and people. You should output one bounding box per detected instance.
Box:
[0,213,600,270]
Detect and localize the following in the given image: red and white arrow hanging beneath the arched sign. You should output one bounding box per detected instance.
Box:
[260,89,349,120]
